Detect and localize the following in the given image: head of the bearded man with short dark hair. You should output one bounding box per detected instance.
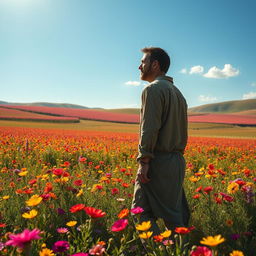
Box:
[139,47,170,82]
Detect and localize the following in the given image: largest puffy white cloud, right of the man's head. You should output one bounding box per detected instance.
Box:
[203,64,239,78]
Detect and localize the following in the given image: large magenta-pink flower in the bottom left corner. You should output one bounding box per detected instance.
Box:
[5,229,41,248]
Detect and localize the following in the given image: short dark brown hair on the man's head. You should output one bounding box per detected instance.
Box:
[141,47,171,73]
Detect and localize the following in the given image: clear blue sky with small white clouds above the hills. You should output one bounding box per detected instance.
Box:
[0,0,256,108]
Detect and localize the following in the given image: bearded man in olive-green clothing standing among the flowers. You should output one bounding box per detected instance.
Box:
[132,47,189,235]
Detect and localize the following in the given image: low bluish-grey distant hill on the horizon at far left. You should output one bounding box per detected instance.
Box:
[0,101,88,109]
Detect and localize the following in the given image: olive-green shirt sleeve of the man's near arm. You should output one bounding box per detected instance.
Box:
[137,86,163,160]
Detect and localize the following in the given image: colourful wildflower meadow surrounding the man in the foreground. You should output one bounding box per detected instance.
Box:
[0,126,256,256]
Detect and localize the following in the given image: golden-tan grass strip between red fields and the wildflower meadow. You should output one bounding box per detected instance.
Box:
[0,120,256,138]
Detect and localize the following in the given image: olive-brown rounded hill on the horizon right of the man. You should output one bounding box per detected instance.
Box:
[189,99,256,114]
